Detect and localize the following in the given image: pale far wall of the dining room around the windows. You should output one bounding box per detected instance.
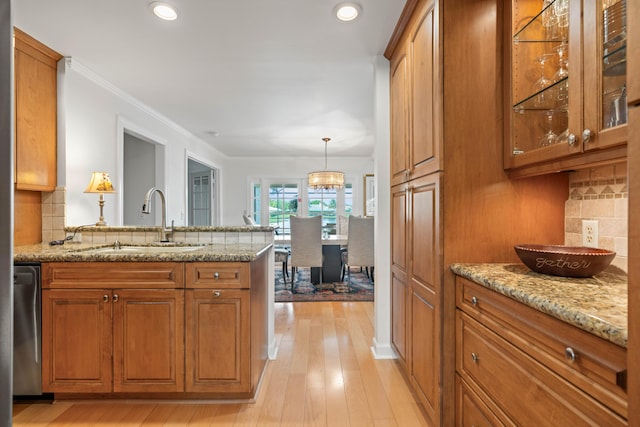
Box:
[222,157,373,225]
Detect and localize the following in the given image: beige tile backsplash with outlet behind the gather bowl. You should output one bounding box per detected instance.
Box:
[564,164,629,271]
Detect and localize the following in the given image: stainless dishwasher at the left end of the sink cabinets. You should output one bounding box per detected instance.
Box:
[13,263,42,396]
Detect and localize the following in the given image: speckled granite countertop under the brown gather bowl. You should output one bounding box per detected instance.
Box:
[451,264,628,347]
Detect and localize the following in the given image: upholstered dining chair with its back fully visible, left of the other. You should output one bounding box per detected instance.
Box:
[289,215,322,291]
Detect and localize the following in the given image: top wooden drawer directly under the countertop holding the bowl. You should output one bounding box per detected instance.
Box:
[456,277,627,418]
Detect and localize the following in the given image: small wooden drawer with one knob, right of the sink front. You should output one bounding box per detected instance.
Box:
[186,262,251,289]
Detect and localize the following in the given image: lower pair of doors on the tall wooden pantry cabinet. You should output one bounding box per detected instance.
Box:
[391,172,442,420]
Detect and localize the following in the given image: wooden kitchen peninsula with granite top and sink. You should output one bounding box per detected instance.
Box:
[14,231,272,399]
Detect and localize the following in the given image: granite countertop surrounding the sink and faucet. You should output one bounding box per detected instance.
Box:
[13,243,272,262]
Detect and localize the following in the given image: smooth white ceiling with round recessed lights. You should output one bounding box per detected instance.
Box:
[13,0,405,157]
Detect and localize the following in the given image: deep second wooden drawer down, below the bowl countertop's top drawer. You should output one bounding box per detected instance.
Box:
[456,310,626,426]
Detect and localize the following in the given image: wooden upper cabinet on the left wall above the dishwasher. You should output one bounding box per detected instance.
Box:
[14,28,62,191]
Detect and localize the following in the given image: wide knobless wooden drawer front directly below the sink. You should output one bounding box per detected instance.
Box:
[42,262,184,289]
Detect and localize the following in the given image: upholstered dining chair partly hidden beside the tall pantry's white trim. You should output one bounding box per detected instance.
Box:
[342,216,375,286]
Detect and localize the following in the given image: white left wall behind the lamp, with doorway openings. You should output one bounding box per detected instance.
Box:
[58,58,227,229]
